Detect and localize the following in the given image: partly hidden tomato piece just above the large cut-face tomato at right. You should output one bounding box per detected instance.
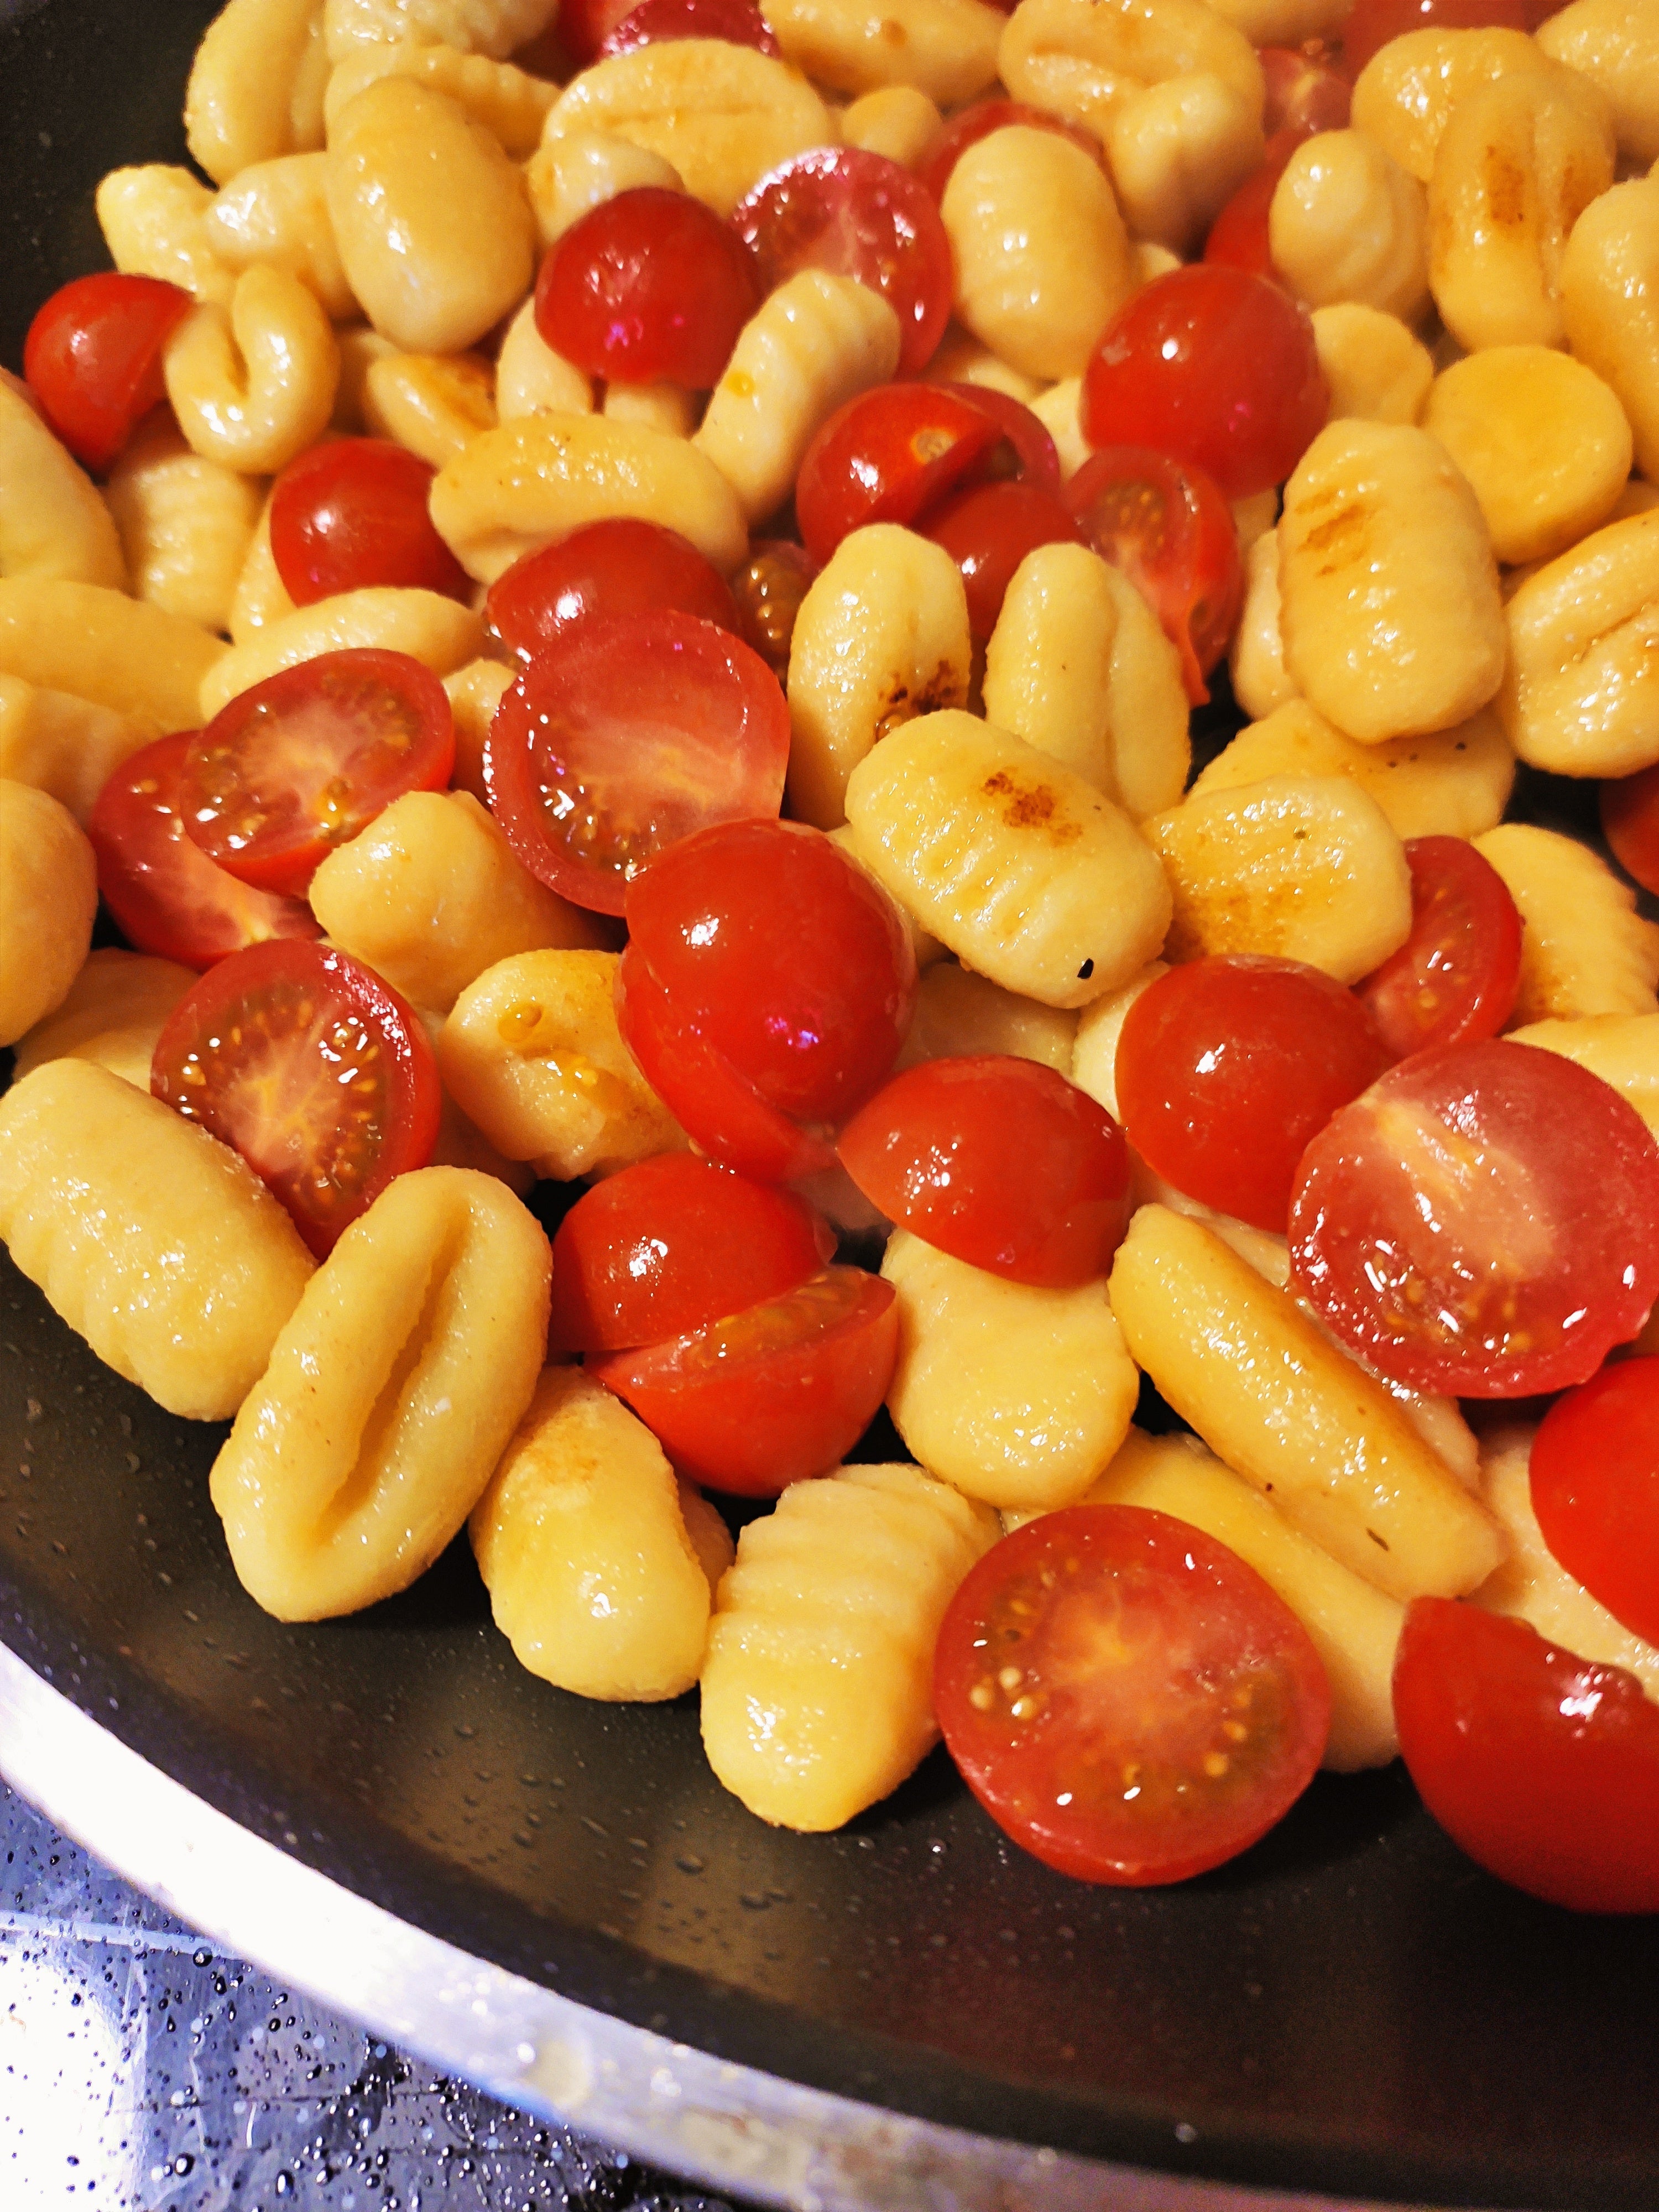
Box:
[1354,836,1520,1060]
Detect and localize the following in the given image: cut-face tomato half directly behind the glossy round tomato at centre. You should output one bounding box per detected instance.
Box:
[484,608,790,914]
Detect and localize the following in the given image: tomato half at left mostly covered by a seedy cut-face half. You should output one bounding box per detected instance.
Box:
[86,730,323,967]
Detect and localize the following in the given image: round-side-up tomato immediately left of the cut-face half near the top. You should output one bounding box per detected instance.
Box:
[535,184,761,392]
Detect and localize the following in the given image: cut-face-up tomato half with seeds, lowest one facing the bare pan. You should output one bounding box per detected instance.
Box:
[933,1506,1332,1887]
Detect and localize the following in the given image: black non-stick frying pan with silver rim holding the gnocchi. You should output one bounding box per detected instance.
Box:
[0,0,1659,2212]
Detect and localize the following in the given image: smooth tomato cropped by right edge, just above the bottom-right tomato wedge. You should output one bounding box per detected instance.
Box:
[1528,1358,1659,1644]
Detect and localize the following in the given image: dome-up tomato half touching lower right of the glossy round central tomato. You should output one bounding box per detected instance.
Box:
[838,1053,1128,1287]
